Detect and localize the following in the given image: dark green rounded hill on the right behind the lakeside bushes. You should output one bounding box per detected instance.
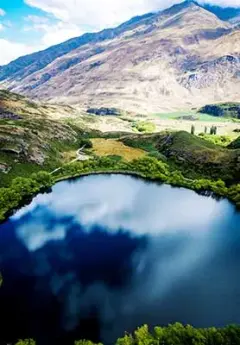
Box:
[122,131,240,183]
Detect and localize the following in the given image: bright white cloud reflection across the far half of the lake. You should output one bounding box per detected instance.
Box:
[13,176,221,251]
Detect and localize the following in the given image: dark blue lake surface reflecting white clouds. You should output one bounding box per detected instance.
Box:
[0,175,240,345]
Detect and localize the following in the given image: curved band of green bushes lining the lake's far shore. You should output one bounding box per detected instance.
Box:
[0,156,240,221]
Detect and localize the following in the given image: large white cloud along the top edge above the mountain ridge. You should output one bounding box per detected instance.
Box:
[25,0,240,30]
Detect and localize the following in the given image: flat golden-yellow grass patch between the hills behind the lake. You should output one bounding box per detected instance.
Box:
[91,139,146,162]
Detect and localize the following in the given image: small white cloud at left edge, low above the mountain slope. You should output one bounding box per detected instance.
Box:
[0,38,36,65]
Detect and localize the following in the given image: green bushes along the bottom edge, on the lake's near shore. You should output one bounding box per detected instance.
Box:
[12,323,240,345]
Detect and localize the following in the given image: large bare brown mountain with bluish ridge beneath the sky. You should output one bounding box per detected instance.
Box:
[0,1,240,113]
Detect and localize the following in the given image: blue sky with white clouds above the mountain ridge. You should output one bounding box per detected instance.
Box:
[0,0,240,65]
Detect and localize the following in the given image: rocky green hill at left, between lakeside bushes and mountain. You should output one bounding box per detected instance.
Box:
[0,90,82,186]
